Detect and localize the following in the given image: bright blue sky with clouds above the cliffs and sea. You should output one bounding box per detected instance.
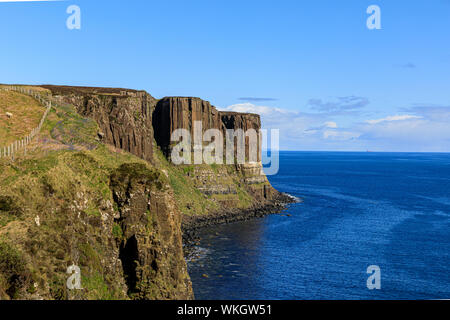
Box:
[0,0,450,152]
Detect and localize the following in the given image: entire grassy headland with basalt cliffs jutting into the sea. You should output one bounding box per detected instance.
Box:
[0,85,292,299]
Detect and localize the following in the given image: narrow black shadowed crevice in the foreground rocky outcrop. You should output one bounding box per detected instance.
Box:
[119,236,139,294]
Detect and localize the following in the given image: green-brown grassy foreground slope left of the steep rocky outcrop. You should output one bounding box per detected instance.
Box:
[0,88,155,299]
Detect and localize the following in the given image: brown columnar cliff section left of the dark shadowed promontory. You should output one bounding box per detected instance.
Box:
[44,86,156,162]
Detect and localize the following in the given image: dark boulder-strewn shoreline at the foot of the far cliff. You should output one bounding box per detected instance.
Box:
[182,193,301,247]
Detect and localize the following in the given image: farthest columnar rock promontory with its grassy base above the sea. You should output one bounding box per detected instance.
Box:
[153,97,279,214]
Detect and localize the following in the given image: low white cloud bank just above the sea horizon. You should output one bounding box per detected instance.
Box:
[223,102,450,152]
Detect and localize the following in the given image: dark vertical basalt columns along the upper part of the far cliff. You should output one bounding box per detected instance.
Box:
[43,85,261,170]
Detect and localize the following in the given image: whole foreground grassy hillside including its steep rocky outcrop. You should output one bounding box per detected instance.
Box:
[0,87,193,299]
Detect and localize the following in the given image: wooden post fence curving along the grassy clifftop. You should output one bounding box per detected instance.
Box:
[0,86,52,159]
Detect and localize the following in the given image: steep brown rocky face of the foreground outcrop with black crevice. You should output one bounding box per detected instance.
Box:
[110,163,193,300]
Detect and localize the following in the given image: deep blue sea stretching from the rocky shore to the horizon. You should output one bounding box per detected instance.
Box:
[188,152,450,299]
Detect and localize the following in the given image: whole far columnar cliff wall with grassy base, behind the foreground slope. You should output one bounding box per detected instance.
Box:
[43,86,280,212]
